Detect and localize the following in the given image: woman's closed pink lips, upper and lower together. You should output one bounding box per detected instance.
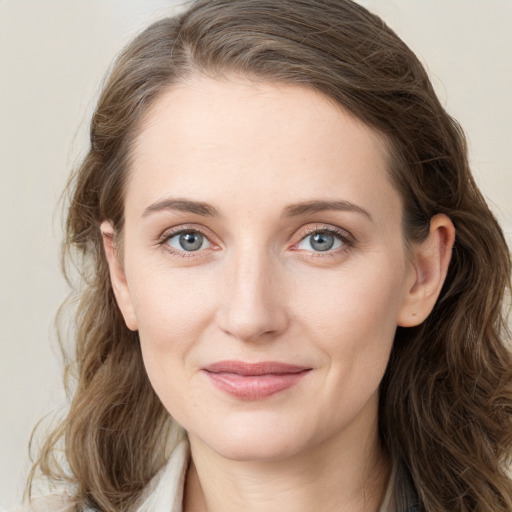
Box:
[203,361,311,400]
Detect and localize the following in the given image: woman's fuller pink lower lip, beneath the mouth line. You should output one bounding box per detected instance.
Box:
[205,370,310,400]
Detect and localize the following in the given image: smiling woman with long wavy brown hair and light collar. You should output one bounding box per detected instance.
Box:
[21,0,512,512]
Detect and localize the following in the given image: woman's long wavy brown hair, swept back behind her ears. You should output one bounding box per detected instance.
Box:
[29,0,512,512]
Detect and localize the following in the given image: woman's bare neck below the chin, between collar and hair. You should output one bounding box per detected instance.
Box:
[184,404,390,512]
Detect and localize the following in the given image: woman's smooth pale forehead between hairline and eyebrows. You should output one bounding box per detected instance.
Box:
[126,78,400,222]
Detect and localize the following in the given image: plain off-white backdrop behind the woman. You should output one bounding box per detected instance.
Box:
[0,0,512,508]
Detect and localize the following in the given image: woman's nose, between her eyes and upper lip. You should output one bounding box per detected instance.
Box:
[218,245,289,342]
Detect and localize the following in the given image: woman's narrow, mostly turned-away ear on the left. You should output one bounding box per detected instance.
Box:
[100,221,137,331]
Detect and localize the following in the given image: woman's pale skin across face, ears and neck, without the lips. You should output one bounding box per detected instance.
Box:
[101,77,455,512]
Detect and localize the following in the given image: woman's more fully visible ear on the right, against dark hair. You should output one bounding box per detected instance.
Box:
[397,214,455,327]
